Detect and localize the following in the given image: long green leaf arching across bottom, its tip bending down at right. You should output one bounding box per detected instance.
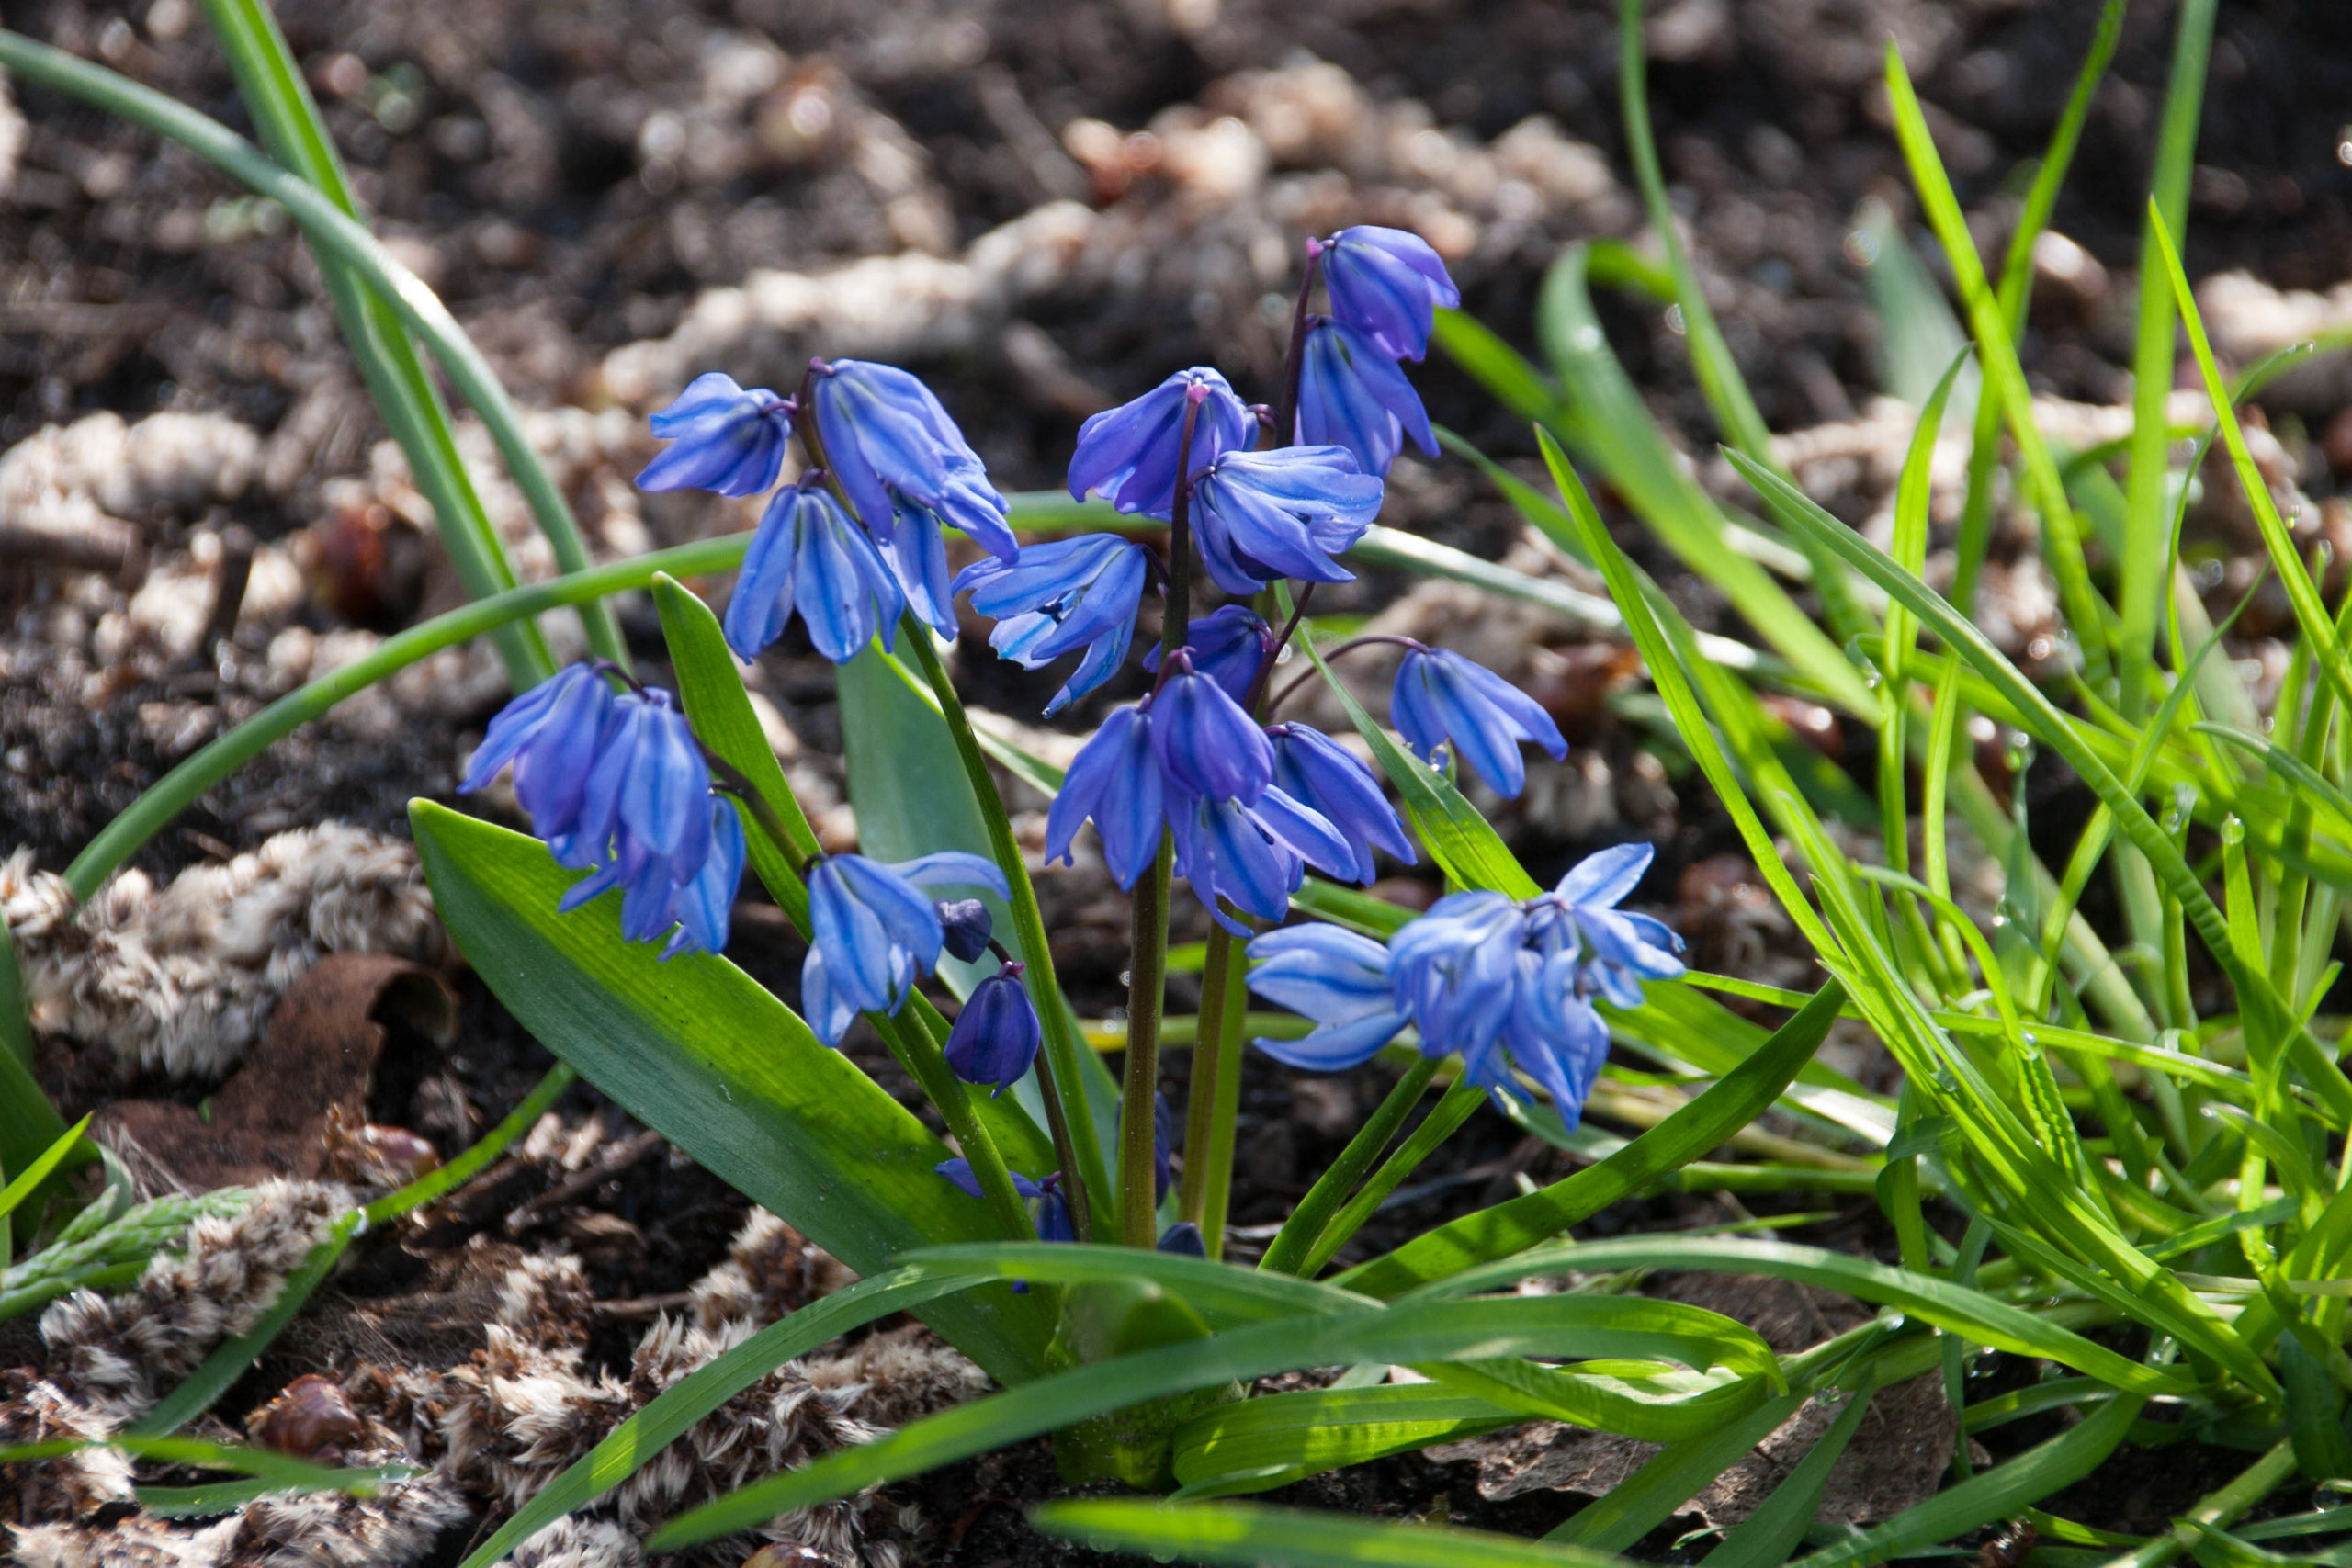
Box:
[647,1295,1776,1551]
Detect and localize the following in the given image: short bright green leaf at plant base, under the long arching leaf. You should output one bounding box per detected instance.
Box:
[1176,1382,1524,1497]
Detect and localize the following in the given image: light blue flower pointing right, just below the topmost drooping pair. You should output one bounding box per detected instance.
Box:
[1193,446,1381,594]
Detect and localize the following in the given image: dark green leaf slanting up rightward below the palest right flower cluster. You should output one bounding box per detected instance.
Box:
[1336,983,1847,1298]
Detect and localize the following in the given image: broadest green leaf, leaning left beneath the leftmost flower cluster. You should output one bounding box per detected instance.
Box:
[409,802,1046,1382]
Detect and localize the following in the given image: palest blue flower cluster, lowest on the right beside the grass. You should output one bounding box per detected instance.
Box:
[1249,844,1681,1126]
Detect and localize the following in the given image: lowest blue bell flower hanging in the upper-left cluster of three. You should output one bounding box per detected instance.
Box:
[724,484,906,663]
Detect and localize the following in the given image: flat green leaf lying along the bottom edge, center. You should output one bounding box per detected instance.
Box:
[1030,1500,1623,1568]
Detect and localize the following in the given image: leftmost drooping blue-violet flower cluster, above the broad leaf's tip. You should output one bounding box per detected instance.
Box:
[458,665,743,959]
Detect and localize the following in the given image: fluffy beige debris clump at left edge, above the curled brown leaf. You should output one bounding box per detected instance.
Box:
[0,823,445,1079]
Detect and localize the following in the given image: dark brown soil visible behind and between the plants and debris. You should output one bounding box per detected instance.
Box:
[0,0,2352,1565]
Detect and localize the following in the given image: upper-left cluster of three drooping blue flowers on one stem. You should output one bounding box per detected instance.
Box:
[638,360,1018,663]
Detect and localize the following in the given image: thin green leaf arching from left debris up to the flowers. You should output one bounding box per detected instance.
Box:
[66,534,751,900]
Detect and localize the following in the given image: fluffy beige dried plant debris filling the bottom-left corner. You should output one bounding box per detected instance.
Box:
[0,1182,986,1568]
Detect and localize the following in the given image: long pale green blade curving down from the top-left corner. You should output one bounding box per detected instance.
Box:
[0,23,628,665]
